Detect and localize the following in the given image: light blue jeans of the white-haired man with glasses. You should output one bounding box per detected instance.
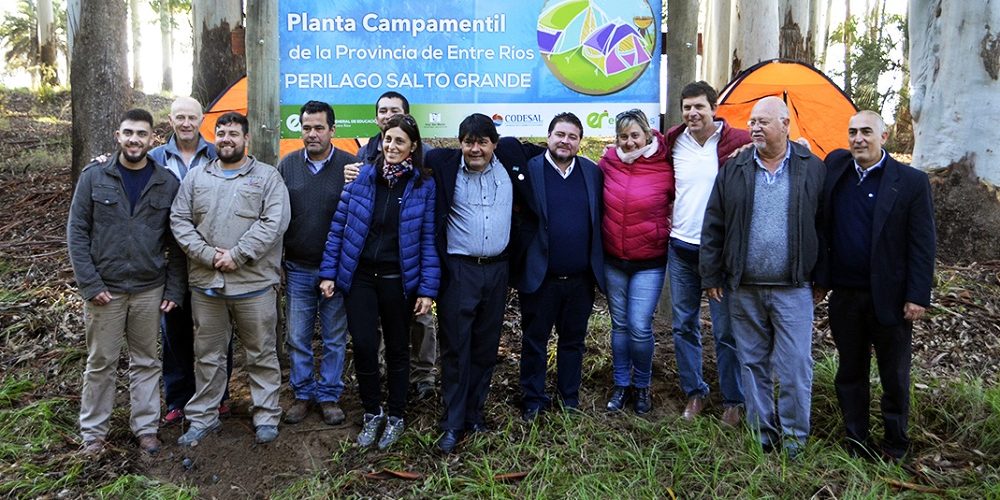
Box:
[729,286,813,449]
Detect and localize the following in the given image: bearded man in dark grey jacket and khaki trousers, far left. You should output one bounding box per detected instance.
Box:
[66,109,185,455]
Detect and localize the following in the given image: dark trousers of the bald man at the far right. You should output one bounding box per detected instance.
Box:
[830,289,913,458]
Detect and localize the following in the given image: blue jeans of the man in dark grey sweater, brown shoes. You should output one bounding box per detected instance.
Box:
[285,261,347,403]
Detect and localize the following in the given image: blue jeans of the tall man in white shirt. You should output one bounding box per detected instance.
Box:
[667,238,743,406]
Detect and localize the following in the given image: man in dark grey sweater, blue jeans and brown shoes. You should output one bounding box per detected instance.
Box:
[278,101,358,425]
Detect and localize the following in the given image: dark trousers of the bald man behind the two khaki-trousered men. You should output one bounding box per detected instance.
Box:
[160,291,233,411]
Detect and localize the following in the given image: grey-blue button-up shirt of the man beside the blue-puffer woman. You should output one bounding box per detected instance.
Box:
[447,155,514,257]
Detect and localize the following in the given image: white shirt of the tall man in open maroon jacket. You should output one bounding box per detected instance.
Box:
[670,121,725,245]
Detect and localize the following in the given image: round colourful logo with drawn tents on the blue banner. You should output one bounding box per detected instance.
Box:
[538,0,657,95]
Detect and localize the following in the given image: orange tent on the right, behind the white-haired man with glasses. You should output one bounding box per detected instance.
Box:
[715,59,858,158]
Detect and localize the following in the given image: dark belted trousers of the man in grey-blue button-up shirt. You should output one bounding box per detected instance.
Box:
[438,258,508,431]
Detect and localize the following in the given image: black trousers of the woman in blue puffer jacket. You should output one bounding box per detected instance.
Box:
[344,267,416,418]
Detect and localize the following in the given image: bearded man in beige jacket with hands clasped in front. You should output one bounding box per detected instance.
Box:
[170,112,290,446]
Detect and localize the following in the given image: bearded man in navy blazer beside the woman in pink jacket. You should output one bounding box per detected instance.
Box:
[514,113,604,421]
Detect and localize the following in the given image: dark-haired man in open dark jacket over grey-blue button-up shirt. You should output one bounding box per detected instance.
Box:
[425,113,544,453]
